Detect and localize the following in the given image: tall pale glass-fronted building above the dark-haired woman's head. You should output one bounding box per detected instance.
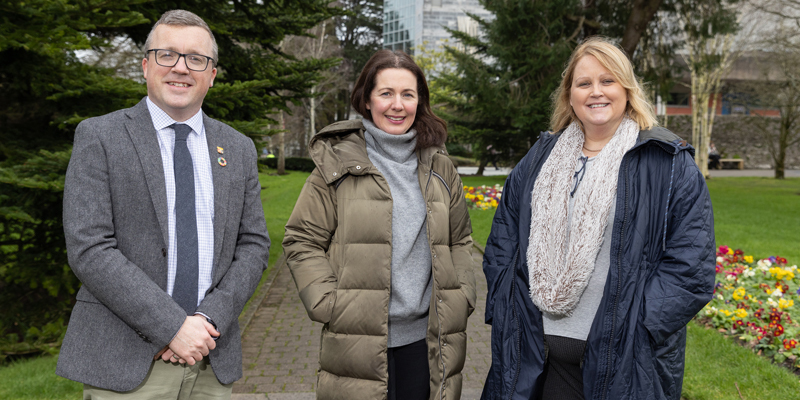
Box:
[383,0,492,54]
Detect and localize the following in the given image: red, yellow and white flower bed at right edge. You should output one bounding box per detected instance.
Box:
[697,246,800,372]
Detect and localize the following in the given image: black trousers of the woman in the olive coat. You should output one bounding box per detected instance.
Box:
[388,339,431,400]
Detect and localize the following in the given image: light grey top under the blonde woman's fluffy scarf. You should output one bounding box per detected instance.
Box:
[542,158,616,340]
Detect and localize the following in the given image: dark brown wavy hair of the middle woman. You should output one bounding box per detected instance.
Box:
[350,50,447,150]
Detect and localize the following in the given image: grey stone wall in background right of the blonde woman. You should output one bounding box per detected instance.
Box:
[659,115,800,169]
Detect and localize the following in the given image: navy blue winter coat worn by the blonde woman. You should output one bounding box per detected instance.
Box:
[481,128,715,400]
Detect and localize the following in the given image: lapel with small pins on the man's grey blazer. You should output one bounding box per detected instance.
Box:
[203,113,233,286]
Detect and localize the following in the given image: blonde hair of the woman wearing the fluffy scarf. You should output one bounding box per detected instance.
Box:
[550,36,658,132]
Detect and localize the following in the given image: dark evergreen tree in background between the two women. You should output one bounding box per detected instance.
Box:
[439,0,582,168]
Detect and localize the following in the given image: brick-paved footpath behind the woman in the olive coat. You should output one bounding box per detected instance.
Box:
[232,248,491,400]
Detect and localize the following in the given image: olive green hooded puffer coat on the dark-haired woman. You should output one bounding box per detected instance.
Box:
[283,121,475,400]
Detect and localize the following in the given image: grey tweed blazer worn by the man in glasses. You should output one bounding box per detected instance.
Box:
[56,100,270,391]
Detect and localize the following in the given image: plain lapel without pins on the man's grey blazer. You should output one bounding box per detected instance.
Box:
[125,100,169,246]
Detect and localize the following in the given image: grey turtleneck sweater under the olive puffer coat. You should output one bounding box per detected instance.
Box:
[363,119,433,347]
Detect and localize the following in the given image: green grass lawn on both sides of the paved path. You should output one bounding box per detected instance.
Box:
[0,172,800,400]
